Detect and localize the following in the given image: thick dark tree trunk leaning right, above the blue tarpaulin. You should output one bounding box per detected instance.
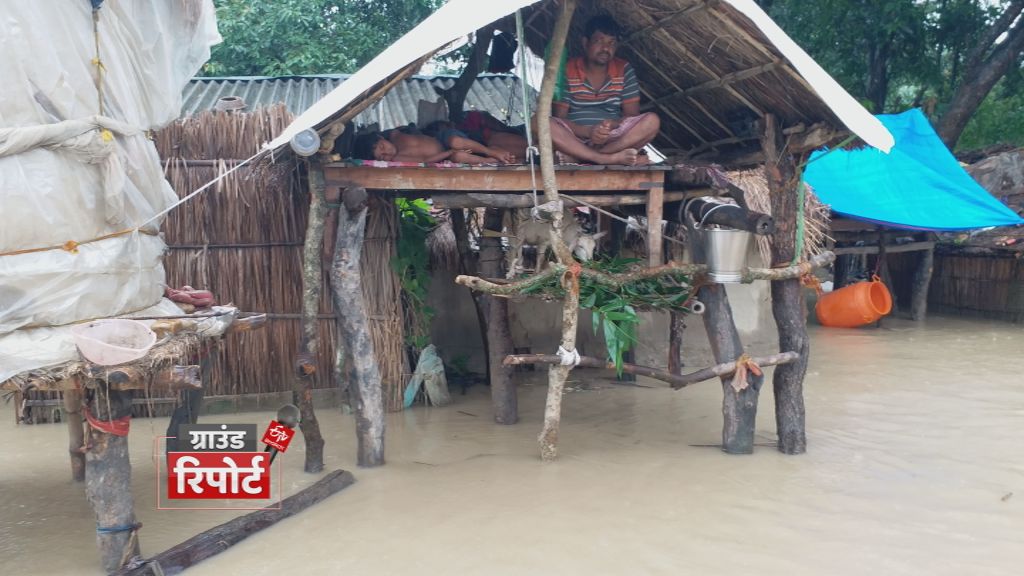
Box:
[936,16,1024,150]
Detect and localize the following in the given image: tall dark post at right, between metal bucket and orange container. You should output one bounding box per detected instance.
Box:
[765,114,811,454]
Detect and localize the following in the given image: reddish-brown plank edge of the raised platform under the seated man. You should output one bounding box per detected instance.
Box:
[324,165,664,192]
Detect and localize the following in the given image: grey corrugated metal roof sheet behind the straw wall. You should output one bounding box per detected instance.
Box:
[181,74,537,129]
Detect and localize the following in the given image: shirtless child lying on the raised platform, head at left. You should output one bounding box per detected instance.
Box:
[352,126,512,164]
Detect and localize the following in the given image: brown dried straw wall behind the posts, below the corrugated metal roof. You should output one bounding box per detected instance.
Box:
[156,106,403,401]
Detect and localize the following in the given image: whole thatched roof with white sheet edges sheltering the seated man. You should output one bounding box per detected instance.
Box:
[268,0,892,162]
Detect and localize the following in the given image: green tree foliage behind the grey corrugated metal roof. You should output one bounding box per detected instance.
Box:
[203,0,443,76]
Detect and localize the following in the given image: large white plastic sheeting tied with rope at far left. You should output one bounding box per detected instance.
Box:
[0,0,220,381]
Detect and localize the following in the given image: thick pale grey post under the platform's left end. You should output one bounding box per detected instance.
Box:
[331,188,384,466]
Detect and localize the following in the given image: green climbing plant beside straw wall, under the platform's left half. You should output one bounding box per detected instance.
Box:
[391,198,437,353]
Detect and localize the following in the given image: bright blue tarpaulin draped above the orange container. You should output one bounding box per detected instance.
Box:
[804,110,1024,230]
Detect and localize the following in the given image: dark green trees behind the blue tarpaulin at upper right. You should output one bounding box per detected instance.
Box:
[760,0,1024,148]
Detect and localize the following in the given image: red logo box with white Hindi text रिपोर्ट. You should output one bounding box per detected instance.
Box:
[167,452,270,500]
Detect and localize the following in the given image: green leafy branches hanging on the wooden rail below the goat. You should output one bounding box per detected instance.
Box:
[523,258,691,375]
